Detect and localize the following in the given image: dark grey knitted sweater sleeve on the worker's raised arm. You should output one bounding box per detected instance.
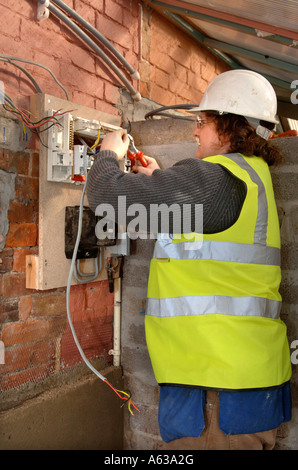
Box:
[86,150,246,233]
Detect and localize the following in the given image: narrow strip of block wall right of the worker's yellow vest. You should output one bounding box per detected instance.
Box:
[271,137,298,450]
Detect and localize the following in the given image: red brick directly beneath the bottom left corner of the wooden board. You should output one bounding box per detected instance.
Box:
[32,292,66,316]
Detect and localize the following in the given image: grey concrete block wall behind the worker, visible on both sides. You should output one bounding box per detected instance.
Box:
[122,120,298,450]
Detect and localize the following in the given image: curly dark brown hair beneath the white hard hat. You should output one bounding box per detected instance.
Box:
[206,112,283,166]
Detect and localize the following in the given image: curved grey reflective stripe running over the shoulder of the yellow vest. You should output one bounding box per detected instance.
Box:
[227,153,268,245]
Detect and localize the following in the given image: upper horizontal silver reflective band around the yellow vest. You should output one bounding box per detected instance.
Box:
[153,236,280,266]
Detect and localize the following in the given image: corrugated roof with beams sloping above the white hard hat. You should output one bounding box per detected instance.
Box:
[146,0,298,119]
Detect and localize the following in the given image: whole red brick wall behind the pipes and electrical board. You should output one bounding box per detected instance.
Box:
[0,0,225,390]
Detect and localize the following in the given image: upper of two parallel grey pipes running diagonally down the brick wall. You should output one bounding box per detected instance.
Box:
[52,0,140,80]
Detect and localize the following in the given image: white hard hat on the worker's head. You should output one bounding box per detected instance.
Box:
[190,69,278,124]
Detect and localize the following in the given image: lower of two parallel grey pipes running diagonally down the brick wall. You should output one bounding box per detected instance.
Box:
[48,3,141,101]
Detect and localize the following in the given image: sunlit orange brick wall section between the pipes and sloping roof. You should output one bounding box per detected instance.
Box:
[140,10,228,105]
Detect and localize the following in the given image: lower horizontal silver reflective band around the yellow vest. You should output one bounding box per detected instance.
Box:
[146,295,281,319]
